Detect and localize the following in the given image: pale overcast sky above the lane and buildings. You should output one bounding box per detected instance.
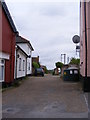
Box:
[6,0,79,69]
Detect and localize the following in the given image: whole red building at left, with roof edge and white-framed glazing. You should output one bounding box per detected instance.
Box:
[0,2,18,83]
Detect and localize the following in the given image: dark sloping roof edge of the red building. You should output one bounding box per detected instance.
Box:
[1,1,18,33]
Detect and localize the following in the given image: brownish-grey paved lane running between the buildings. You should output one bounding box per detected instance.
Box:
[2,75,88,118]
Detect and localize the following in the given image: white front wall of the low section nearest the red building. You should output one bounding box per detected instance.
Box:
[14,45,27,79]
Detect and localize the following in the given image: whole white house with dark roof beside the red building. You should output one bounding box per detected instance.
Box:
[14,36,34,79]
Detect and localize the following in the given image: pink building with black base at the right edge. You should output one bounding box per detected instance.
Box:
[80,2,90,91]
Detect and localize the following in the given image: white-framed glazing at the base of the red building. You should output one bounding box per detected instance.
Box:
[0,59,5,82]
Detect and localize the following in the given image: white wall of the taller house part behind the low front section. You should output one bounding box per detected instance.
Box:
[17,43,32,75]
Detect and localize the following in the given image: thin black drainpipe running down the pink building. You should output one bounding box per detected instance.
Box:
[84,1,87,91]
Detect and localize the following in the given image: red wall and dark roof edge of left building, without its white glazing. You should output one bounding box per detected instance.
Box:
[0,2,17,84]
